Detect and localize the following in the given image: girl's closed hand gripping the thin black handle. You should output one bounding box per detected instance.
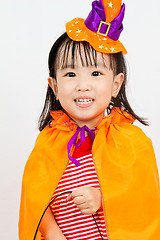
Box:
[67,187,101,215]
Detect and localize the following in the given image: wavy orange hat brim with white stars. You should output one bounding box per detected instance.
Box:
[66,18,127,54]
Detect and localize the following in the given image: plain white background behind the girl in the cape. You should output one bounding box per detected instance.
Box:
[0,0,160,240]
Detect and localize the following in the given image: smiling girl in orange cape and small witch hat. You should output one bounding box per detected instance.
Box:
[19,0,160,240]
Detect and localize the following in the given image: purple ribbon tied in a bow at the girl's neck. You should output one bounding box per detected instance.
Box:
[67,125,95,167]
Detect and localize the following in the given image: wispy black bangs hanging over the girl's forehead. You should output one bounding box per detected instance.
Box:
[55,38,105,70]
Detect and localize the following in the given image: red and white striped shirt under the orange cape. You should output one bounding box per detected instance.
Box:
[42,137,108,240]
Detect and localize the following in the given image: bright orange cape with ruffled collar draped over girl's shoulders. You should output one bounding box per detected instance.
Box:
[19,108,160,240]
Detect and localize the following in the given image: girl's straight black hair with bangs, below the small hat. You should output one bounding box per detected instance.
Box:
[38,33,148,131]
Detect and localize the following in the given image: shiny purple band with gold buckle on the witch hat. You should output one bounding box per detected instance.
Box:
[84,0,125,41]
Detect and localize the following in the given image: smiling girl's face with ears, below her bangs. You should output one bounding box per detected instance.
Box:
[48,47,124,129]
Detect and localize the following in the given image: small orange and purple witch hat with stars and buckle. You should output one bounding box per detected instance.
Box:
[66,0,127,54]
